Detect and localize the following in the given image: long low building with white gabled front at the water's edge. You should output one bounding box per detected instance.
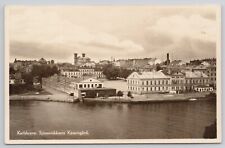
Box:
[42,75,116,98]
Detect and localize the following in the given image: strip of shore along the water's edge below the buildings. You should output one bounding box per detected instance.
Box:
[9,87,214,103]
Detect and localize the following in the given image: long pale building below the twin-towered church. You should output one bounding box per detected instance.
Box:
[61,68,104,79]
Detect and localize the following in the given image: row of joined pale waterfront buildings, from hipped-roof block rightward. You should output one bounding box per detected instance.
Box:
[127,71,212,94]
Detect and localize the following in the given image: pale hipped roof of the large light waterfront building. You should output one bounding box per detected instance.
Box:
[128,71,170,79]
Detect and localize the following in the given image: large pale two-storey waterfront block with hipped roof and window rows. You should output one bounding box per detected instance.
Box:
[127,71,170,94]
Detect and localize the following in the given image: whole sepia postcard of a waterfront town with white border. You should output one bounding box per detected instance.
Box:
[5,5,221,144]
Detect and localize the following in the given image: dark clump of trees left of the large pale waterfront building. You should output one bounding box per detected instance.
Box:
[103,64,133,80]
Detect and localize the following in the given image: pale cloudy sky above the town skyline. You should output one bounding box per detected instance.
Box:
[6,5,219,63]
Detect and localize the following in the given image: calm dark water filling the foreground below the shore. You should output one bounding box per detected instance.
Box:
[10,100,216,139]
